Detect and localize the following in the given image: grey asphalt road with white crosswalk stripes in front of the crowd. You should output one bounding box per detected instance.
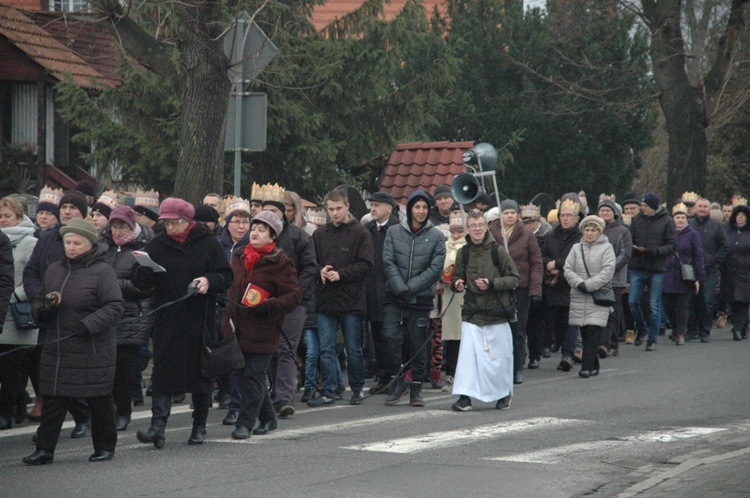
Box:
[0,329,750,497]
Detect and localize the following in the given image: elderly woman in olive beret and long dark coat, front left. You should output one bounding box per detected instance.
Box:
[23,218,123,465]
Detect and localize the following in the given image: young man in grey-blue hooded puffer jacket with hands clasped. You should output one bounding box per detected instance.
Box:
[383,190,445,407]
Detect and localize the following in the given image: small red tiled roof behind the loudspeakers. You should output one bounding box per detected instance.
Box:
[380,142,474,204]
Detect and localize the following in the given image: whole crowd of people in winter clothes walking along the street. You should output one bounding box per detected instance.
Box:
[0,182,750,465]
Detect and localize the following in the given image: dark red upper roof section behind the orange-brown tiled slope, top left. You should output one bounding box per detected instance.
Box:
[29,12,122,86]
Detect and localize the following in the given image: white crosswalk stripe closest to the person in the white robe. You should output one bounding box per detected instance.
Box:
[344,417,582,453]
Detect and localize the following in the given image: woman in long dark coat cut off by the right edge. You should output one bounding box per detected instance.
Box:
[721,206,750,341]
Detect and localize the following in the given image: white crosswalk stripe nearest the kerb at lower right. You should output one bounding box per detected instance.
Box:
[484,427,727,464]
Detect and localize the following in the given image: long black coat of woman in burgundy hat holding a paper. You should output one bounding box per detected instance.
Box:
[133,224,232,395]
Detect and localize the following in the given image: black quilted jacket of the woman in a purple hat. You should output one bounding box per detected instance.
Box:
[101,227,153,346]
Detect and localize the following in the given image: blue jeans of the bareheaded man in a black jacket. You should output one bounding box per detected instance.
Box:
[318,313,365,393]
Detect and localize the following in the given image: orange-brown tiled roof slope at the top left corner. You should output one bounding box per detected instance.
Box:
[0,5,111,88]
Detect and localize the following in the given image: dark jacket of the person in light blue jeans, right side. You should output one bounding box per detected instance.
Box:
[628,207,677,273]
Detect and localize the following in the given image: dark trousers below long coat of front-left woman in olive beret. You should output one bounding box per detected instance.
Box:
[36,394,117,453]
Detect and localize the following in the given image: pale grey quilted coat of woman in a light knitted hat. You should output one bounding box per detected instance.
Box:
[565,235,616,327]
